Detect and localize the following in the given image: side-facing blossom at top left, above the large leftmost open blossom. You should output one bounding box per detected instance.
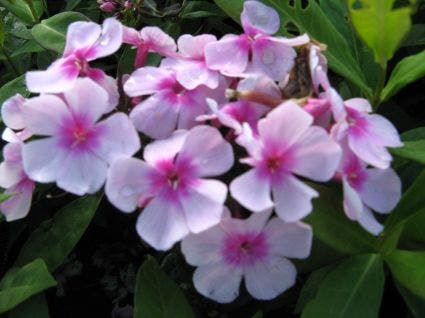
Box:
[25,18,122,112]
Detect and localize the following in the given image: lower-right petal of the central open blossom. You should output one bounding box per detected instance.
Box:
[181,180,227,233]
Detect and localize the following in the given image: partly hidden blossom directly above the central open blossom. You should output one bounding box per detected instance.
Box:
[124,66,227,139]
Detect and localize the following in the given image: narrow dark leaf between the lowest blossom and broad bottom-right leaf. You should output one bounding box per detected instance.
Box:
[294,265,335,314]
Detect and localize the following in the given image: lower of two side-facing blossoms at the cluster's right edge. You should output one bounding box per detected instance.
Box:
[340,149,401,235]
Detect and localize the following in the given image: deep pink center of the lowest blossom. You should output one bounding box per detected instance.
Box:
[221,232,269,266]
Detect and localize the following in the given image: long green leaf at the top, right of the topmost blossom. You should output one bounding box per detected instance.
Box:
[214,0,372,97]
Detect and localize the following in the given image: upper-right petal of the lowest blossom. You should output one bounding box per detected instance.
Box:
[264,218,313,259]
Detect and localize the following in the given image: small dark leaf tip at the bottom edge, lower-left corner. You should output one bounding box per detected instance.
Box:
[8,293,49,318]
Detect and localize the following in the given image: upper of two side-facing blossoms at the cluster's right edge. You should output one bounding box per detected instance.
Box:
[332,98,403,169]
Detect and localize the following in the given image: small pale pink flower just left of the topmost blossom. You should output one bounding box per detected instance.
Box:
[161,34,219,89]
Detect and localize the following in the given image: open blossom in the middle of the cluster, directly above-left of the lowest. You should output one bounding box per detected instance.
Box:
[105,126,233,250]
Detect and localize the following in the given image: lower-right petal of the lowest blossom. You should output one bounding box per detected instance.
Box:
[244,256,297,300]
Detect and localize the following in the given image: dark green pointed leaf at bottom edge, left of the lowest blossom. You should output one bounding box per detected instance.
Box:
[134,256,195,318]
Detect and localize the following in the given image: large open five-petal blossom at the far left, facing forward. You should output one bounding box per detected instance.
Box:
[23,78,140,195]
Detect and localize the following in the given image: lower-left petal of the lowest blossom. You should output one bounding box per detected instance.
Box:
[193,263,242,303]
